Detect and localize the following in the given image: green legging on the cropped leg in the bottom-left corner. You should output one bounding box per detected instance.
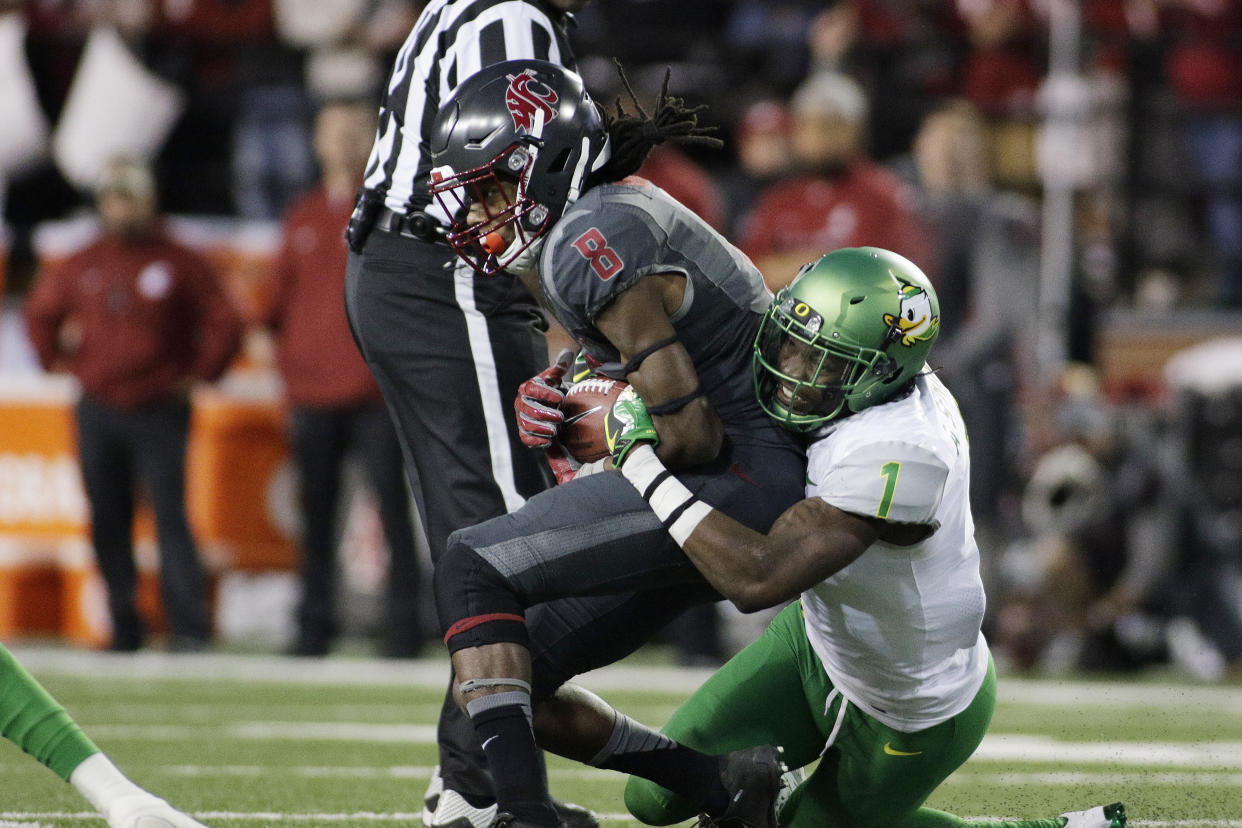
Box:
[0,644,99,782]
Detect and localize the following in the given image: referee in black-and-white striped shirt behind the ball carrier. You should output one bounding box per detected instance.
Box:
[345,0,596,828]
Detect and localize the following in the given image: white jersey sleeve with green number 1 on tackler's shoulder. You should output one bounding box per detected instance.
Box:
[807,441,949,524]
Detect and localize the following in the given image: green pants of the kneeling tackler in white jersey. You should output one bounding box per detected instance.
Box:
[626,603,1063,828]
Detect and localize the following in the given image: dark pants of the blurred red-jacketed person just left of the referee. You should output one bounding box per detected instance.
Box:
[289,401,424,655]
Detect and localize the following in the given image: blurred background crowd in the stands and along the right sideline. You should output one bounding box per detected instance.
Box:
[0,0,1242,678]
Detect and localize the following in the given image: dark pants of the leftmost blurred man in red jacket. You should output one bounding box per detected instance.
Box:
[77,395,211,649]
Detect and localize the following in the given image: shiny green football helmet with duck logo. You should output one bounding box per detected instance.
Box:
[753,247,940,431]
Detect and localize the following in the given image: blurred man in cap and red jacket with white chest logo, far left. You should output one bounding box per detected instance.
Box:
[25,160,242,650]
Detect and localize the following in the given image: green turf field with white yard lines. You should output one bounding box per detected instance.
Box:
[0,647,1242,828]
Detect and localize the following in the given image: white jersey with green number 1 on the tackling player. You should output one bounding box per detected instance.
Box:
[802,374,987,732]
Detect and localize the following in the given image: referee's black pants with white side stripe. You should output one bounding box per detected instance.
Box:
[345,228,551,798]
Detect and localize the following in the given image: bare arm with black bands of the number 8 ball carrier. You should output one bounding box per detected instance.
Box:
[595,273,724,468]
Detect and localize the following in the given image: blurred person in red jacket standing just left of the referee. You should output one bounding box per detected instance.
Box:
[263,101,424,658]
